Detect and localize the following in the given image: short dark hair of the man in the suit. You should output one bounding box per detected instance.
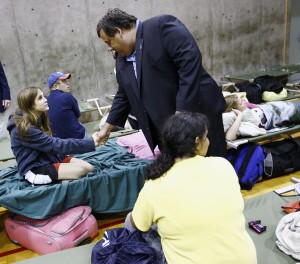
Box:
[97,8,137,38]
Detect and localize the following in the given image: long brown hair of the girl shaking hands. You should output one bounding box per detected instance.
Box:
[14,87,52,139]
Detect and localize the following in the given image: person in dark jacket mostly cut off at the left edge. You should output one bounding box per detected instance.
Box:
[0,61,11,139]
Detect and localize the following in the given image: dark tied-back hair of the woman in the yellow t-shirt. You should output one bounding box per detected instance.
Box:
[145,112,208,180]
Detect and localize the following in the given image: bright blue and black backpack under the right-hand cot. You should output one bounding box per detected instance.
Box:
[227,143,265,190]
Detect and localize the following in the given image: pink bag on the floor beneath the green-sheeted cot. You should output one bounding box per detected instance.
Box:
[5,206,98,255]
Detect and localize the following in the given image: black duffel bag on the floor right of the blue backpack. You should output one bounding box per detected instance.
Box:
[262,138,300,178]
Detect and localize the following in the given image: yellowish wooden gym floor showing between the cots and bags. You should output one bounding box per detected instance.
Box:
[0,172,300,264]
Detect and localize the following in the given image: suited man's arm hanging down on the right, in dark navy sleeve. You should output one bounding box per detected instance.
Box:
[159,16,210,112]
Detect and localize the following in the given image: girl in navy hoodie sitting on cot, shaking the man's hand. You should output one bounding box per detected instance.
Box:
[7,87,105,184]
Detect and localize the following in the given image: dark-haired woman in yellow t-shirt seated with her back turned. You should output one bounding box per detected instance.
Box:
[125,112,257,264]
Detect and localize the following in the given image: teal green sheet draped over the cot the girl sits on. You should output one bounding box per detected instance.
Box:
[0,139,151,219]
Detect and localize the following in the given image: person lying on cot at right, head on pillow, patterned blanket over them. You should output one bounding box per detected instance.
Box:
[223,94,300,140]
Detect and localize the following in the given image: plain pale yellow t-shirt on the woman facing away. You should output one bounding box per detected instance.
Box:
[132,156,257,264]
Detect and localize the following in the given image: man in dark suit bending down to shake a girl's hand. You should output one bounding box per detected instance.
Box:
[97,8,226,157]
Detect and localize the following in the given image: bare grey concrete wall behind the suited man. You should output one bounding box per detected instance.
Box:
[0,0,286,116]
